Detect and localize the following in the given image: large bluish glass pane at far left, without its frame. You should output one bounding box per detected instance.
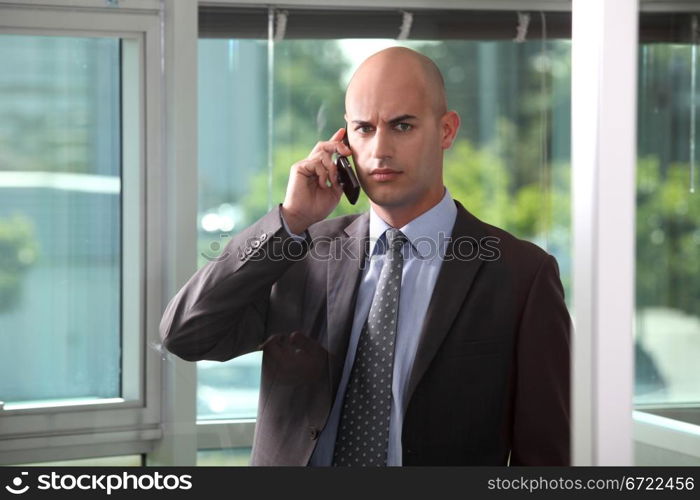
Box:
[0,35,121,408]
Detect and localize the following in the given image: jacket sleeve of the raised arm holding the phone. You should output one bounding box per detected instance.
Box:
[160,205,309,361]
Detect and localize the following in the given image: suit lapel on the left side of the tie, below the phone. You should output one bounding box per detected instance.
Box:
[326,212,369,401]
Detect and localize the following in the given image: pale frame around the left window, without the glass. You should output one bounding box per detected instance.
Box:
[0,0,164,464]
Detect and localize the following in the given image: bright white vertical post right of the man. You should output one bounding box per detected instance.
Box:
[571,0,639,465]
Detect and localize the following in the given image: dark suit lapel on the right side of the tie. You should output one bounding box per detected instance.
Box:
[406,200,486,405]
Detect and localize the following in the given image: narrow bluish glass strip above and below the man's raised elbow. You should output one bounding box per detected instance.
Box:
[197,40,268,419]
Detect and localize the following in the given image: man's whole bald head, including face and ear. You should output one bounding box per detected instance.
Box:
[345,47,459,227]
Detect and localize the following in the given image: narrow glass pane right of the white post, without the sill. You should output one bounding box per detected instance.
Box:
[635,44,700,406]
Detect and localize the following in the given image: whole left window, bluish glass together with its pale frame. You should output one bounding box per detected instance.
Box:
[0,2,161,464]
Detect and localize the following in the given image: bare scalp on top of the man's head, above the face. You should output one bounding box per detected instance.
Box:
[345,47,447,118]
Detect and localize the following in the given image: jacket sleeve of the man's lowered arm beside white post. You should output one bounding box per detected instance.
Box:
[510,255,572,466]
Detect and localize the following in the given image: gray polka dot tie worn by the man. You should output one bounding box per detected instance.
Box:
[333,228,407,467]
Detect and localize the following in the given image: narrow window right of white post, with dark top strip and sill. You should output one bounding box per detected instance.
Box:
[634,19,700,465]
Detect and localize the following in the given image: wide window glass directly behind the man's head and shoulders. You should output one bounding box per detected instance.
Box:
[198,34,571,418]
